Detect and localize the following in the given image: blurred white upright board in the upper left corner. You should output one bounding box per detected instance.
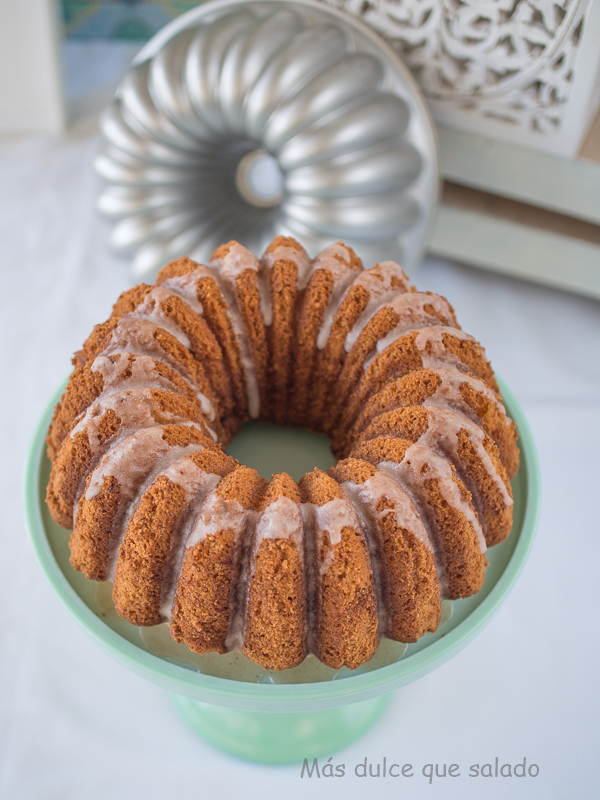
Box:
[0,0,64,133]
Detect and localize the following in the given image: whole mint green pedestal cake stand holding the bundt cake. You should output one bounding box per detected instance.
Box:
[25,376,540,764]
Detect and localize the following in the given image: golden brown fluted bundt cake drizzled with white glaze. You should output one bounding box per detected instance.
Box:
[47,237,519,670]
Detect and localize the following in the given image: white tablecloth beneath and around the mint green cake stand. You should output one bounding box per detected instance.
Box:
[0,42,600,800]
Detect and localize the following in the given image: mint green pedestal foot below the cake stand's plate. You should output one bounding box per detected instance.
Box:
[173,694,391,764]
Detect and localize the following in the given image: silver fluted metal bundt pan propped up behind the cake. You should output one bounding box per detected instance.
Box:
[95,0,438,278]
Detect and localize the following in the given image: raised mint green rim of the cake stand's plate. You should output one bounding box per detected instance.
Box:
[24,375,541,713]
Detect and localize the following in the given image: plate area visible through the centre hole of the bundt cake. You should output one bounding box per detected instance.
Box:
[227,422,336,481]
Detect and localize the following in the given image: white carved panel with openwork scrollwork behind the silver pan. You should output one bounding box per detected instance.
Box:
[324,0,600,157]
